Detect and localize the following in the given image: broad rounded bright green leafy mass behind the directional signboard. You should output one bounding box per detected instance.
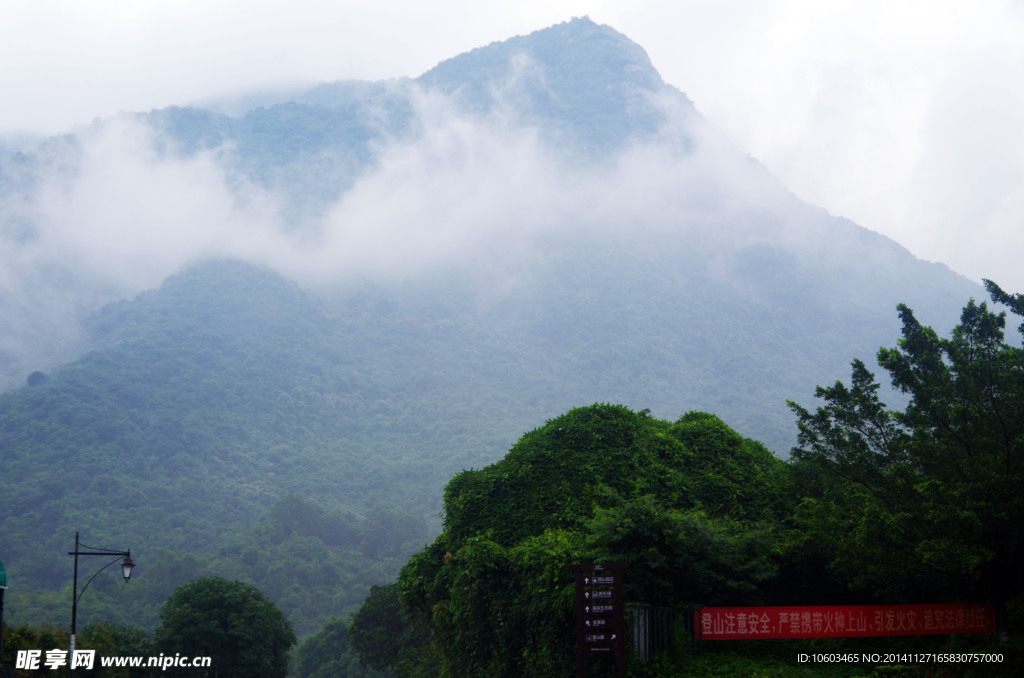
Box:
[362,405,786,678]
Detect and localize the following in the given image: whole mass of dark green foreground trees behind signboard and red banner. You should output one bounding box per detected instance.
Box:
[331,284,1024,676]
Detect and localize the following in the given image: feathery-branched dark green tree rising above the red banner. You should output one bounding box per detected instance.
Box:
[790,281,1024,627]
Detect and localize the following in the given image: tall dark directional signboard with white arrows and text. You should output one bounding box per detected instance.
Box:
[567,562,629,678]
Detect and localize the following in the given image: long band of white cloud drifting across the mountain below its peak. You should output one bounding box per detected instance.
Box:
[4,77,790,319]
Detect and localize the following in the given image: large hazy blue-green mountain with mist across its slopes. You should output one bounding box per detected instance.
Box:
[0,18,982,633]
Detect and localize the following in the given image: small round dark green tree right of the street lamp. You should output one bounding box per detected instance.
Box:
[156,577,296,678]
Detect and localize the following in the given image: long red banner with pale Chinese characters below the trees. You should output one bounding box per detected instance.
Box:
[696,603,995,640]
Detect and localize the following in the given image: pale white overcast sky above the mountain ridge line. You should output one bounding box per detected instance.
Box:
[0,0,1024,292]
